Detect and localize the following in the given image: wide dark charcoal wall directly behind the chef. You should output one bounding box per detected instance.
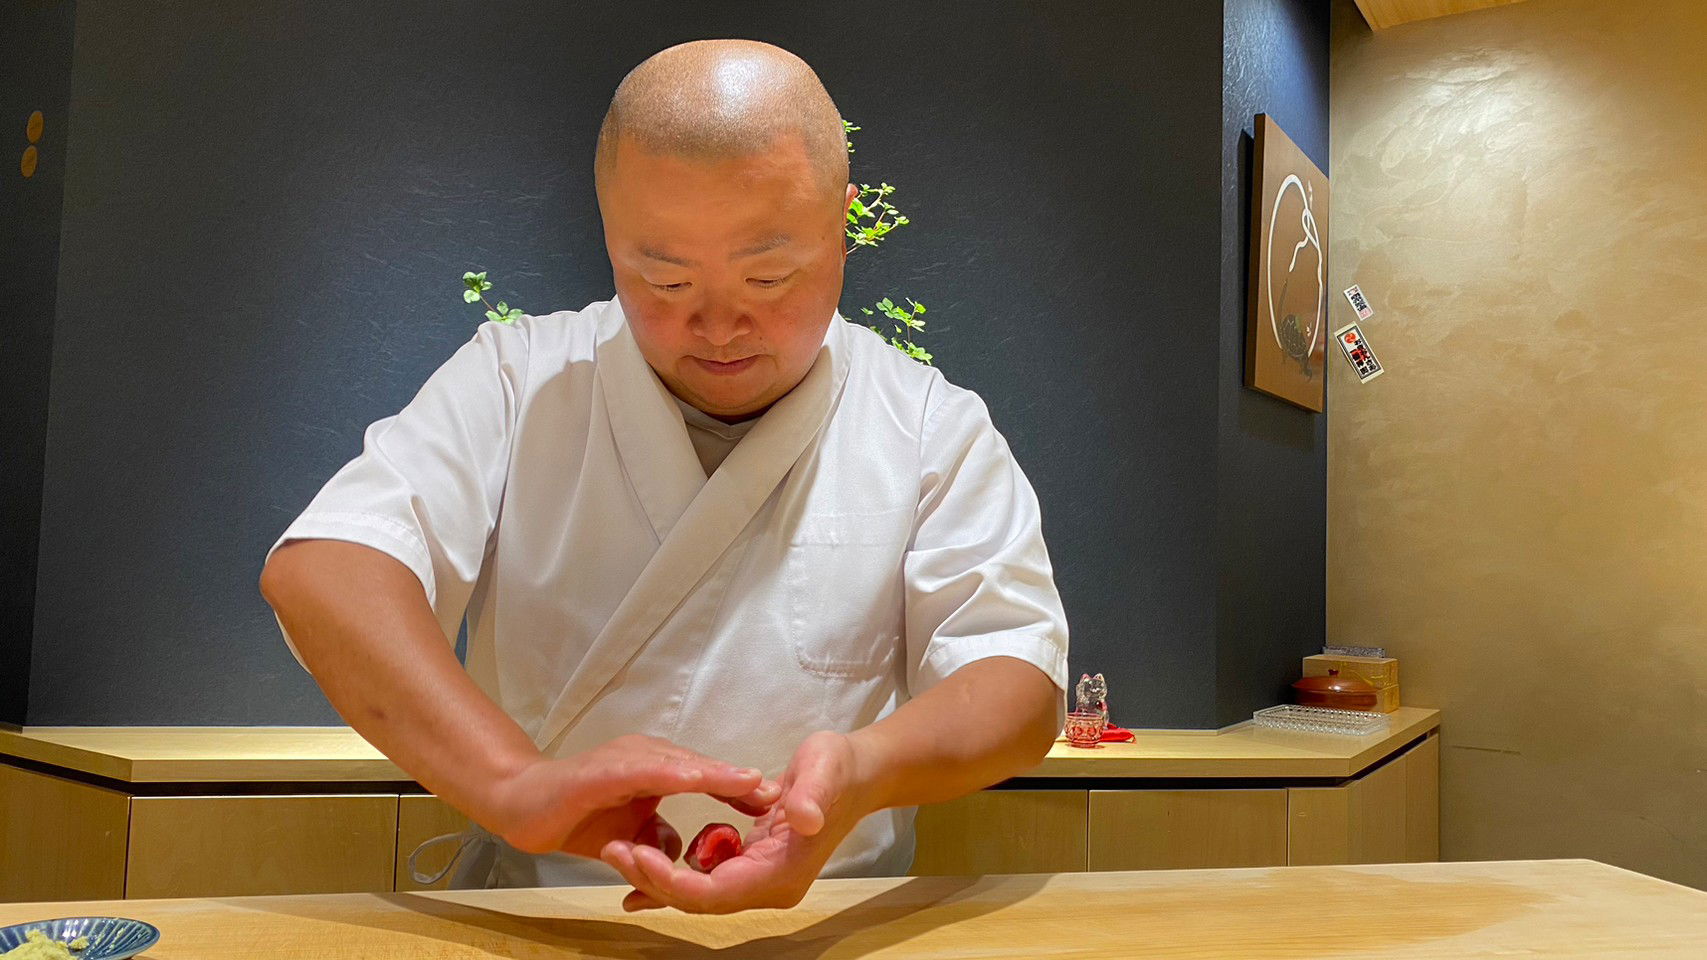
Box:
[6,0,1325,726]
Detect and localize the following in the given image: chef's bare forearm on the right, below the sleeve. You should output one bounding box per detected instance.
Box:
[852,656,1062,810]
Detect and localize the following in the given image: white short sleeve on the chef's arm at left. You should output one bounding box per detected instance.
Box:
[263,318,527,663]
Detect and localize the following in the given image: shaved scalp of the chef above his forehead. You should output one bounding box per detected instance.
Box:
[594,39,848,200]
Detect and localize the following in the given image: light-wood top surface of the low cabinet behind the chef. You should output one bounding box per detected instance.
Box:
[0,707,1441,784]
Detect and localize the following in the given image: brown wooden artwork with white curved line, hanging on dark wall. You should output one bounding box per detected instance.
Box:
[1244,113,1328,413]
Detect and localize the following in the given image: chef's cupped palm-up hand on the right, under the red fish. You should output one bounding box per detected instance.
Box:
[601,731,876,914]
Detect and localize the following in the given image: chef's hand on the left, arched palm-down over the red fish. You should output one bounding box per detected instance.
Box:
[485,735,780,863]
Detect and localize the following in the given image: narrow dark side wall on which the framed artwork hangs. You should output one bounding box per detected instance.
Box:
[1214,0,1340,726]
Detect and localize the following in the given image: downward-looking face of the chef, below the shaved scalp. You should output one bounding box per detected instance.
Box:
[599,137,859,420]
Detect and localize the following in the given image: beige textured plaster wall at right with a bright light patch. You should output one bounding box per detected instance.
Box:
[1328,0,1707,887]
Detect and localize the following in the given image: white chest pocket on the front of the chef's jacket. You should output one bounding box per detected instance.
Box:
[785,511,912,678]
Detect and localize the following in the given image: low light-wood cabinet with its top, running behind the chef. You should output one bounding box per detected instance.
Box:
[0,707,1441,902]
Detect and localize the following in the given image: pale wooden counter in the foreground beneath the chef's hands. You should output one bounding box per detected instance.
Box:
[0,861,1707,960]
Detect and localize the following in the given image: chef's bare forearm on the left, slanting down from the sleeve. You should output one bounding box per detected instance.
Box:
[261,540,539,822]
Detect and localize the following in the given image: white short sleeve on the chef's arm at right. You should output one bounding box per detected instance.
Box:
[905,381,1067,719]
